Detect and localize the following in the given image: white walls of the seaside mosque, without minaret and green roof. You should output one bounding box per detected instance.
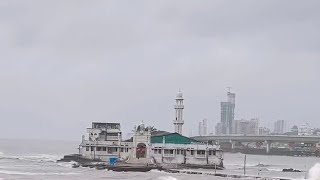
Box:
[80,123,223,166]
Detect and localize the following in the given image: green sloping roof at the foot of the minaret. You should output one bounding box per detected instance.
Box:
[151,133,200,144]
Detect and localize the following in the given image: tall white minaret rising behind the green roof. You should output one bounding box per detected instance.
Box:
[173,89,184,134]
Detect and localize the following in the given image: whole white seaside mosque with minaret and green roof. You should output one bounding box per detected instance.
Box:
[80,90,223,167]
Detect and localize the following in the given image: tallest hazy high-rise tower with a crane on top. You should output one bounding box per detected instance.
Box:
[220,92,236,134]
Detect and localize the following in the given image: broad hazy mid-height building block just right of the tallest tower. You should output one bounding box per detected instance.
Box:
[233,119,259,135]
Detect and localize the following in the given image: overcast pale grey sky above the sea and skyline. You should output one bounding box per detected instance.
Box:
[0,0,320,141]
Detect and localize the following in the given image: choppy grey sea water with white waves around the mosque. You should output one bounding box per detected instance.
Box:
[0,139,320,180]
